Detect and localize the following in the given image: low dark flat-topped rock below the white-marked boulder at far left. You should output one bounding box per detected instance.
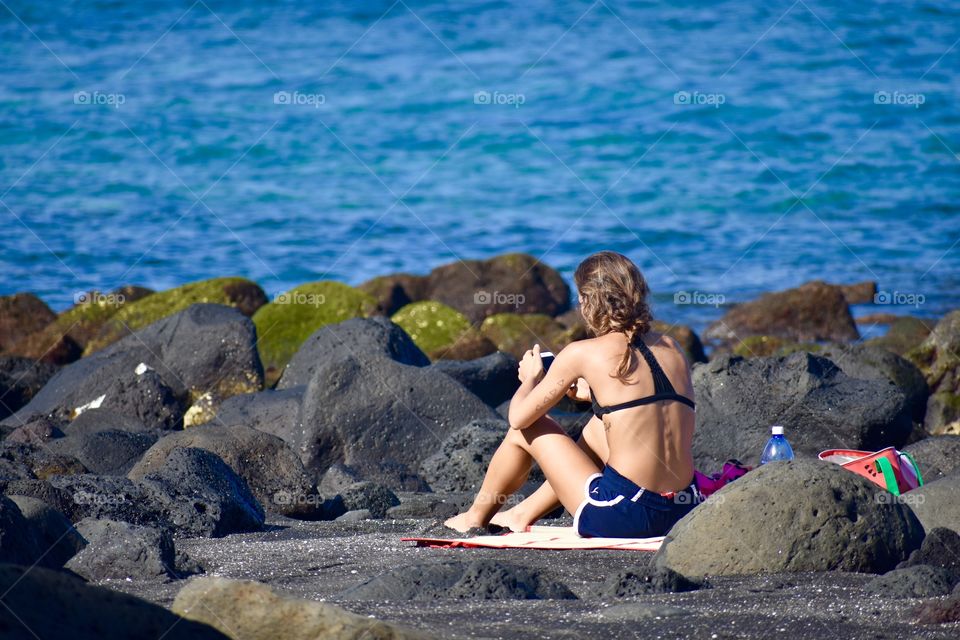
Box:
[47,431,157,476]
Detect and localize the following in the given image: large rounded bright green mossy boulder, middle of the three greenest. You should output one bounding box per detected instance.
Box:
[253,280,378,386]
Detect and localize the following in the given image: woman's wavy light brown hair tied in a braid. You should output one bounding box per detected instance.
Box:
[573,251,653,380]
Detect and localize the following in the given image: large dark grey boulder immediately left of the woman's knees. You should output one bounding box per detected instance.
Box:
[296,355,496,489]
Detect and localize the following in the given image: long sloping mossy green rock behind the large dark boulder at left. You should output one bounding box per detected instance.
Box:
[83,278,267,356]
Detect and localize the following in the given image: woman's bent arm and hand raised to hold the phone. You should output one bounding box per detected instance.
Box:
[509,343,580,429]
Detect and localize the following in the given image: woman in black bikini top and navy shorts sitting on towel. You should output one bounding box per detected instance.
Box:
[446,251,698,538]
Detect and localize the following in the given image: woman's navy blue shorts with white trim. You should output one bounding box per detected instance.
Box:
[573,465,700,538]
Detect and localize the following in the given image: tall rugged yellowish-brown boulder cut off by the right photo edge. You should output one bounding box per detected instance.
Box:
[906,311,960,435]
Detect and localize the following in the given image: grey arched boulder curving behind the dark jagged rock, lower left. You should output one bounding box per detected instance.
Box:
[128,425,323,518]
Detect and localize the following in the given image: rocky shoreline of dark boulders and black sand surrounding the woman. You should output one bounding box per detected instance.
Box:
[0,254,960,638]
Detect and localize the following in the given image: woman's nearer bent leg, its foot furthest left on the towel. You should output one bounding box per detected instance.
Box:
[445,416,600,531]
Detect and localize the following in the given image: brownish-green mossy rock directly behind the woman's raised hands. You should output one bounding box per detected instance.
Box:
[480,313,586,358]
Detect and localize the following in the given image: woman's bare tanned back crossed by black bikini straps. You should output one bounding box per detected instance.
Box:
[578,332,695,492]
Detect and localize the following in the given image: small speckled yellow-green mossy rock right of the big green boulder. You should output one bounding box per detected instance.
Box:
[391,300,497,360]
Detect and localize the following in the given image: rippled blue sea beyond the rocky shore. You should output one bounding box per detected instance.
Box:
[0,0,960,336]
